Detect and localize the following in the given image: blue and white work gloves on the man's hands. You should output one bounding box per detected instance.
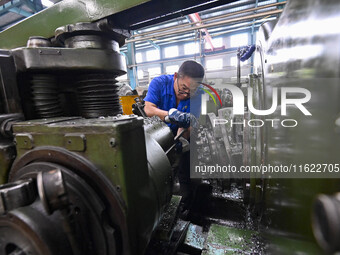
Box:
[164,108,198,128]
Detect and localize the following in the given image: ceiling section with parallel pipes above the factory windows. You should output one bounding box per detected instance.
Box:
[121,0,284,52]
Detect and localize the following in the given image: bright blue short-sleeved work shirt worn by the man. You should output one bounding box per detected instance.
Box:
[144,75,202,135]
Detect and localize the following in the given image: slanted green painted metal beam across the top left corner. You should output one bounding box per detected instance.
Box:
[0,0,150,49]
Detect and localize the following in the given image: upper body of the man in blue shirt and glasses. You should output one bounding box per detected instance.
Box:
[144,60,204,138]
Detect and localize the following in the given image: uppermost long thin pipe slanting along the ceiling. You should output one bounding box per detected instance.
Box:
[131,2,286,38]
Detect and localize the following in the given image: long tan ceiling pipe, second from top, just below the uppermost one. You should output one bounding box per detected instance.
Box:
[126,10,282,43]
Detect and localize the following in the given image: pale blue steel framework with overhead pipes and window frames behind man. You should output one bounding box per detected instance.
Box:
[122,0,285,85]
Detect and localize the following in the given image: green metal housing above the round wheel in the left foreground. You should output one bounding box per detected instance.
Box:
[11,115,171,254]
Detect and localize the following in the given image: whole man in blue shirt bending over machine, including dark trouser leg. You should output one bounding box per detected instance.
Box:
[144,60,204,217]
